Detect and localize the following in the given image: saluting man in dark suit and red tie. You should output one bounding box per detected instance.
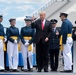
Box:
[31,12,51,72]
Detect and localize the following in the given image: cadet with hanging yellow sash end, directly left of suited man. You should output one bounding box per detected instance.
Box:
[21,16,35,72]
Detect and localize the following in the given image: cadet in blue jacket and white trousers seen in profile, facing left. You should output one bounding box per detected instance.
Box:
[60,13,73,72]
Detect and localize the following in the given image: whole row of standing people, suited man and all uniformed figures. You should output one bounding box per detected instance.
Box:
[0,12,73,72]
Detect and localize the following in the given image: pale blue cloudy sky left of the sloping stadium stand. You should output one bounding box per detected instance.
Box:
[0,0,48,28]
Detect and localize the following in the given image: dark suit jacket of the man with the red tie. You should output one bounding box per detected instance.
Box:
[31,19,51,44]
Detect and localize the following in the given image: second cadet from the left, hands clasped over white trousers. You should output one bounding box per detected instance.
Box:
[6,18,20,72]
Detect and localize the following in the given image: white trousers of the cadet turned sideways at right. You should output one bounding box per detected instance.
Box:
[63,37,73,70]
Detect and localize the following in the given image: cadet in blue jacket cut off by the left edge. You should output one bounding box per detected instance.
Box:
[0,15,6,72]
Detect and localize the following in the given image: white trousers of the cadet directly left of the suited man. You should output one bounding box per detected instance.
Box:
[21,40,33,69]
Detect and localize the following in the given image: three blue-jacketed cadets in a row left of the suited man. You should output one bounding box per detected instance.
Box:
[0,15,35,72]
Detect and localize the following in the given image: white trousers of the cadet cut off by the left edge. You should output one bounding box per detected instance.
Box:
[0,39,4,70]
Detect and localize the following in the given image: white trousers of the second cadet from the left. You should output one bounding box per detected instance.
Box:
[7,41,18,69]
